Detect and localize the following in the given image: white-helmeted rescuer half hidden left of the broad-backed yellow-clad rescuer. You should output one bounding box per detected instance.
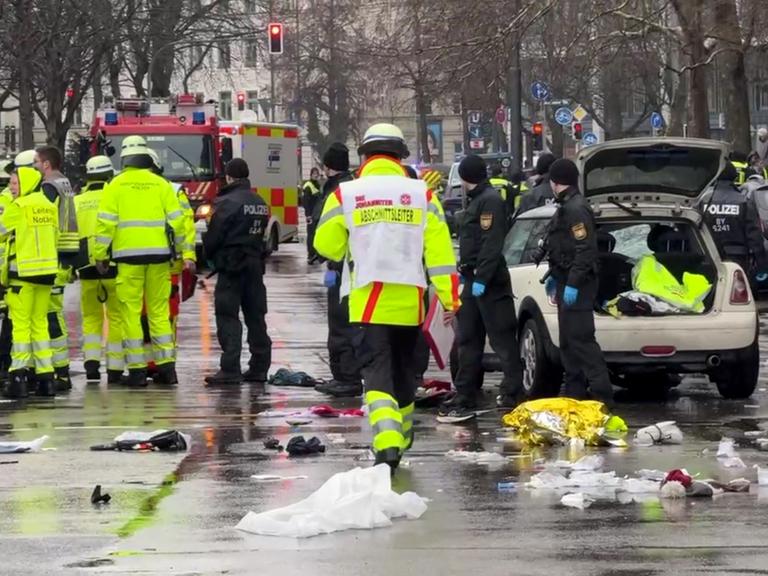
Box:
[75,156,125,384]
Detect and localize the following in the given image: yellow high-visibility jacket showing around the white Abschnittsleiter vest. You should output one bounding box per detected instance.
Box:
[314,156,460,326]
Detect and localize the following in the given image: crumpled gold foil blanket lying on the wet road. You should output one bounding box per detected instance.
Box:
[502,398,627,446]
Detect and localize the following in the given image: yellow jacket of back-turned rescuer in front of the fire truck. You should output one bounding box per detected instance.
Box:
[93,168,184,264]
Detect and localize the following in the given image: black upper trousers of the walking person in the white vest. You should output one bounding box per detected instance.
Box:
[355,324,421,408]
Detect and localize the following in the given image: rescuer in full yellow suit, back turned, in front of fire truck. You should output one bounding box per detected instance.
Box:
[93,136,188,386]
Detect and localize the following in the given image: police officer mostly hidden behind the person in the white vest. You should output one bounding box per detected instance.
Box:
[312,142,363,397]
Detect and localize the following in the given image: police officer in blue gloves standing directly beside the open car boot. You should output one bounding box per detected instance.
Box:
[546,159,613,405]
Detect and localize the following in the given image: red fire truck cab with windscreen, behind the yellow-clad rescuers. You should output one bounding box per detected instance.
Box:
[90,94,223,208]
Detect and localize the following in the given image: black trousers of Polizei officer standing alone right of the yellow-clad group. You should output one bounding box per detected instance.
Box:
[214,258,272,380]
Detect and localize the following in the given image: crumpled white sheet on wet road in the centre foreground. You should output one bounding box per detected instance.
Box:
[235,464,427,538]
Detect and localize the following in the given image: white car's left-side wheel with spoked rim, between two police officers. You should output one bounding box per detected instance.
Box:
[520,318,563,398]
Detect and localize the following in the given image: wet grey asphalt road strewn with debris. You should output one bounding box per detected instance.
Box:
[0,245,768,576]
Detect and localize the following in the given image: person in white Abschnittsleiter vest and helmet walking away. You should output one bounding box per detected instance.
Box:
[314,124,459,473]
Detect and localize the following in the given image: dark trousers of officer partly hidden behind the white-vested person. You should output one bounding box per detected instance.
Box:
[328,278,361,384]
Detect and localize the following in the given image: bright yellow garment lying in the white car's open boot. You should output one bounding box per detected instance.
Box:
[632,255,712,314]
